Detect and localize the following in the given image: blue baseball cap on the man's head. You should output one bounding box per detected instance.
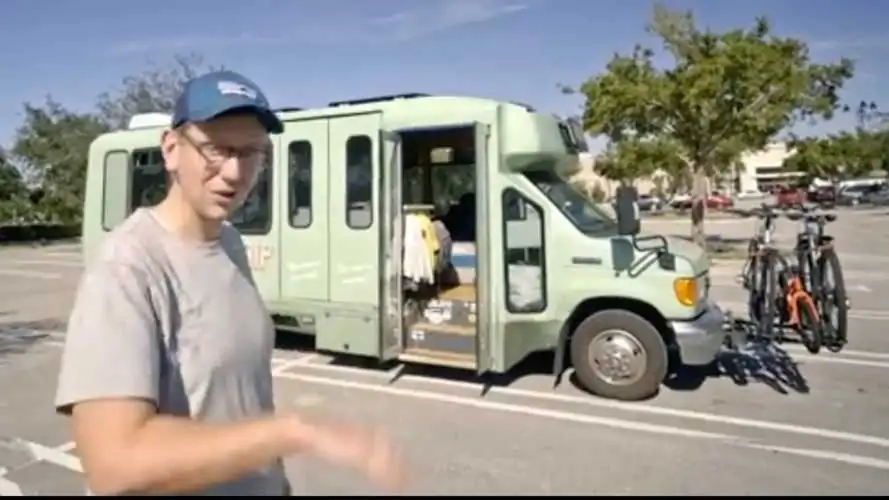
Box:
[173,71,284,134]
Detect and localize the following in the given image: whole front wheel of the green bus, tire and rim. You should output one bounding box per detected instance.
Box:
[571,309,668,401]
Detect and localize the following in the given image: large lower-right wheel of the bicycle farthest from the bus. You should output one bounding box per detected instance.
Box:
[816,247,849,352]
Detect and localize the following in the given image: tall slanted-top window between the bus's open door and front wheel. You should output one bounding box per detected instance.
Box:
[502,188,546,313]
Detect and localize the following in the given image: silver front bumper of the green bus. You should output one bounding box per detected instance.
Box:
[670,300,726,366]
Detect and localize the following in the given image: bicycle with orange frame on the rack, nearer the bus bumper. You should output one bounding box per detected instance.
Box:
[741,204,823,353]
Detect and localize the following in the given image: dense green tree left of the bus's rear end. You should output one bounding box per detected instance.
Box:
[11,98,107,223]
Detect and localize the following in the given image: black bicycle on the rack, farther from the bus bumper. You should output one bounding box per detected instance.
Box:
[787,208,849,352]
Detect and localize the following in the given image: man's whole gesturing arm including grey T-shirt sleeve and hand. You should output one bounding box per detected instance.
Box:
[56,252,394,495]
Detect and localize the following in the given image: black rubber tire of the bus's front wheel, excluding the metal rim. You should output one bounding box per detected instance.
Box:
[571,309,669,401]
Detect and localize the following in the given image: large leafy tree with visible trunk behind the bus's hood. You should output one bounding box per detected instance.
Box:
[565,4,853,244]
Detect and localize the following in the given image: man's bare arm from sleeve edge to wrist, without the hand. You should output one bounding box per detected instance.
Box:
[73,399,315,495]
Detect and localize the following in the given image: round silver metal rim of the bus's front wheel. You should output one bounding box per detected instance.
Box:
[588,330,648,386]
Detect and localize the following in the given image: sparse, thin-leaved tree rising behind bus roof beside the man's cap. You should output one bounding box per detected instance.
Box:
[96,53,222,130]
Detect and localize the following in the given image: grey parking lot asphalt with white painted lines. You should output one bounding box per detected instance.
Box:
[0,210,889,495]
